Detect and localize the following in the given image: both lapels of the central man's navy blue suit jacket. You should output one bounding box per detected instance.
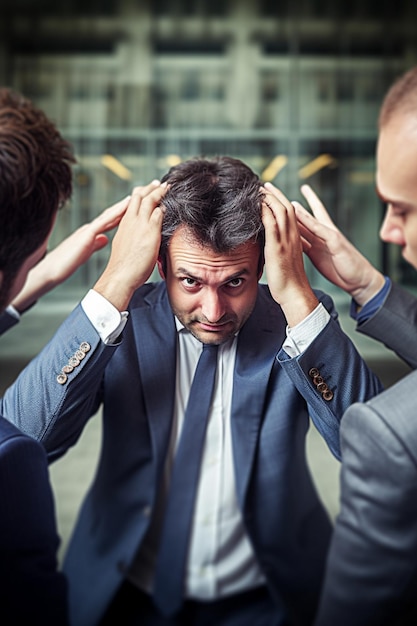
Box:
[132,283,286,503]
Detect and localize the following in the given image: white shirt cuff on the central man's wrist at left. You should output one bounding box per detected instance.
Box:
[81,289,129,344]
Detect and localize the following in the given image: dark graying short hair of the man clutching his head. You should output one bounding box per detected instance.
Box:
[160,156,265,271]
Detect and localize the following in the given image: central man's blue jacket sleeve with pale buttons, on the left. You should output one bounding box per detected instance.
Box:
[0,305,117,461]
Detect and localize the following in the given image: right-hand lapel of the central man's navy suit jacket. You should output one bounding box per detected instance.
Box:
[231,290,286,504]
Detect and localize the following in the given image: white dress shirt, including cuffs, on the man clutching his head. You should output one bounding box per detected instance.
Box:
[81,291,329,600]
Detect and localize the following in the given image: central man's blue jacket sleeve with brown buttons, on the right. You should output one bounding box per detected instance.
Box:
[278,294,383,459]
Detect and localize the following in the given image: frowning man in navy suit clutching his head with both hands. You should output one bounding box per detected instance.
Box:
[2,152,381,626]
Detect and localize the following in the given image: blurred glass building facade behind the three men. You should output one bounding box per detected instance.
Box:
[0,0,417,296]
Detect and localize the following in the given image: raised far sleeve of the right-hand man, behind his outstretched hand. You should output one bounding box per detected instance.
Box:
[356,283,417,369]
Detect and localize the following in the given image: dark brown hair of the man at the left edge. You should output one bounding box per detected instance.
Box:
[0,88,75,308]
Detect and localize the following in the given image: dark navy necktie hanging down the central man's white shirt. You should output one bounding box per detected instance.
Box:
[153,345,218,615]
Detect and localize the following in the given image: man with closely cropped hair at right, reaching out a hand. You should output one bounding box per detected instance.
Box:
[296,67,417,626]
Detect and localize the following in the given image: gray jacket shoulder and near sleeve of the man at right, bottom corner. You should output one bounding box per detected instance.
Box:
[315,372,417,626]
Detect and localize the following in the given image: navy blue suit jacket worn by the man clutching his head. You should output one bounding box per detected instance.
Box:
[1,282,381,626]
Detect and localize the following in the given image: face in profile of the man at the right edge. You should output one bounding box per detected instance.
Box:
[376,114,417,269]
